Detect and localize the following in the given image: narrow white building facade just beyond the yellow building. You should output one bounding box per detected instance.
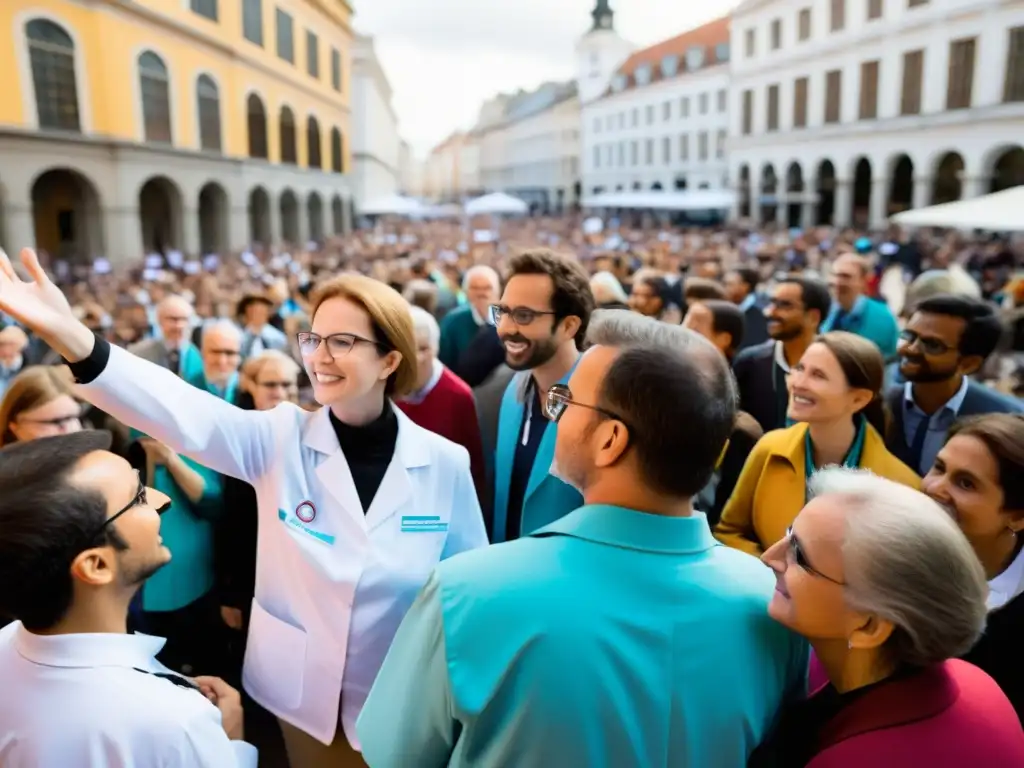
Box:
[352,36,402,204]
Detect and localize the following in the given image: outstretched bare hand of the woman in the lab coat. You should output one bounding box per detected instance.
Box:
[0,248,93,359]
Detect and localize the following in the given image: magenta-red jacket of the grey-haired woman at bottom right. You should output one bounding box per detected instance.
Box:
[807,657,1024,768]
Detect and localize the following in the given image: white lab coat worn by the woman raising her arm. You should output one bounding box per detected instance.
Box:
[82,347,487,749]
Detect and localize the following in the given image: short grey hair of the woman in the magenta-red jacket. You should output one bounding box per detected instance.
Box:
[809,467,988,667]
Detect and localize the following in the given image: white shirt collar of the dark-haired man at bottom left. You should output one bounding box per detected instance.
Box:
[13,622,167,669]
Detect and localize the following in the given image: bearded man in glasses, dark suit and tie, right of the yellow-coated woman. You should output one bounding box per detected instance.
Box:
[886,294,1024,476]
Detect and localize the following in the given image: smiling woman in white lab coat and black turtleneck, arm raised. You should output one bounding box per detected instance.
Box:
[0,250,486,768]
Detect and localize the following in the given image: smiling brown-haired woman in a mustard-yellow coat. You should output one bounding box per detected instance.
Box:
[715,331,921,556]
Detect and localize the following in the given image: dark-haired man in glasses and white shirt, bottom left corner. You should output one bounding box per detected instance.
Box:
[0,431,256,768]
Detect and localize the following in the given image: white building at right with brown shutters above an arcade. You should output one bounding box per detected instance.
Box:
[728,0,1024,228]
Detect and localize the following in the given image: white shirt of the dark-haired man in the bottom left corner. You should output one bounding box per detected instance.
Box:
[0,622,257,768]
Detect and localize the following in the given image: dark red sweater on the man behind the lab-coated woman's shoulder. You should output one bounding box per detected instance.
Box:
[395,368,484,495]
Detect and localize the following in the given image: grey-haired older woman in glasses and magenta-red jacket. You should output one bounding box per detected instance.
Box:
[749,468,1024,768]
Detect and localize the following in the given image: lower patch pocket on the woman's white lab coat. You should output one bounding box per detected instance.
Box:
[245,599,306,710]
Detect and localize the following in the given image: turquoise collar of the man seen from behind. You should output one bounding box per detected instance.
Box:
[530,504,718,554]
